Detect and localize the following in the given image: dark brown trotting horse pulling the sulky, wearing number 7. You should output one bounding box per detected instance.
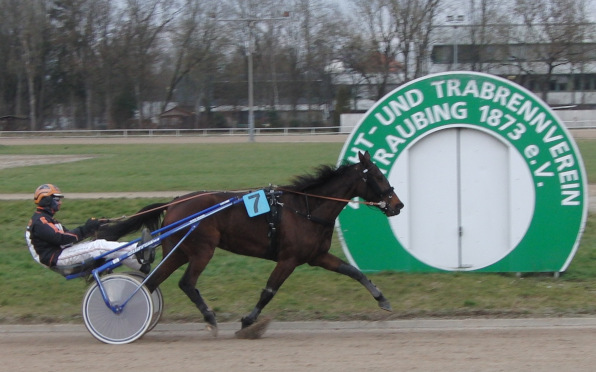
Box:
[99,153,403,333]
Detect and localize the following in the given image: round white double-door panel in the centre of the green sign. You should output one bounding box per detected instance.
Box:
[390,127,534,270]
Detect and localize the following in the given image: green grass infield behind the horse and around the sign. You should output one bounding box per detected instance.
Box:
[0,140,596,323]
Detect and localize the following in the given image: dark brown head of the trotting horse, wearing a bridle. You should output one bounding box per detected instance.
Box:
[358,151,404,217]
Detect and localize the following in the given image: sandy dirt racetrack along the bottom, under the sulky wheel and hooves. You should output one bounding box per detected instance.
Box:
[0,318,596,372]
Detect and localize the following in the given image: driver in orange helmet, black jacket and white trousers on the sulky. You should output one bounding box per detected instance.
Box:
[25,184,151,274]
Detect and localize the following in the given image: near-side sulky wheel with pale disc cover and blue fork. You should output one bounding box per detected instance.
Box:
[83,274,153,345]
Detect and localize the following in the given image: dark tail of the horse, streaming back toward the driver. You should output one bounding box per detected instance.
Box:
[97,203,170,240]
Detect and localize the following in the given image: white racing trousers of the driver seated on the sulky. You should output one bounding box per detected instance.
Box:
[56,239,141,271]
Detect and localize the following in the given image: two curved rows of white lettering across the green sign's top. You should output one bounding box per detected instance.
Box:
[348,79,582,206]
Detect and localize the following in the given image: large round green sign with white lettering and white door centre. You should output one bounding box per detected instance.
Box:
[338,72,587,272]
